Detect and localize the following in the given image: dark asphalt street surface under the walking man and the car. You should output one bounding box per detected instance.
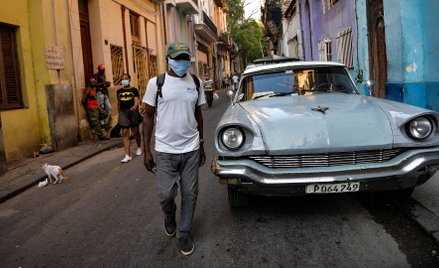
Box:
[0,91,439,267]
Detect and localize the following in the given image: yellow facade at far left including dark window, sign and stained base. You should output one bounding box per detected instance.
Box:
[0,0,78,166]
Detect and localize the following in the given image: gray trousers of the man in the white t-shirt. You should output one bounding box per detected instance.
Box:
[155,150,200,238]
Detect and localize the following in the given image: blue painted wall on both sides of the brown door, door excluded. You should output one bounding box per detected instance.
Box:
[355,0,439,111]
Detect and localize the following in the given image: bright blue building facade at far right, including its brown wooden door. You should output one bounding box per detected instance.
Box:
[356,0,439,111]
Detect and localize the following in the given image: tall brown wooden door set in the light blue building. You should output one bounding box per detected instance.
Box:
[367,0,387,98]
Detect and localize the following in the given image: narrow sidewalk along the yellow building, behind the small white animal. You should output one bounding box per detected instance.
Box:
[0,138,122,203]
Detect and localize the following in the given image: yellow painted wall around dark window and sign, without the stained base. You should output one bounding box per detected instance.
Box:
[0,0,78,162]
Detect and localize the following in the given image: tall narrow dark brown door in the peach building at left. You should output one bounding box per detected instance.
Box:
[78,0,94,85]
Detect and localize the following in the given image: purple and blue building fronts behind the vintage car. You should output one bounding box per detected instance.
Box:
[278,0,439,111]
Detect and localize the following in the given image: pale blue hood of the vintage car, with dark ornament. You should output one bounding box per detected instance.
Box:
[240,93,394,154]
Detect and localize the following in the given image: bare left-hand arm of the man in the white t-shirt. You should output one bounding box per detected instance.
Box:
[142,103,155,173]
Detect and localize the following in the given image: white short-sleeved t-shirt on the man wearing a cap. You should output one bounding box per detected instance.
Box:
[143,73,206,154]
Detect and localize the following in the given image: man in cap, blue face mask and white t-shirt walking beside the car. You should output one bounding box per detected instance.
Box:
[143,42,206,255]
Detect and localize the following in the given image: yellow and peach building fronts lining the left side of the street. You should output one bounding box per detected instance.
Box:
[0,0,166,171]
